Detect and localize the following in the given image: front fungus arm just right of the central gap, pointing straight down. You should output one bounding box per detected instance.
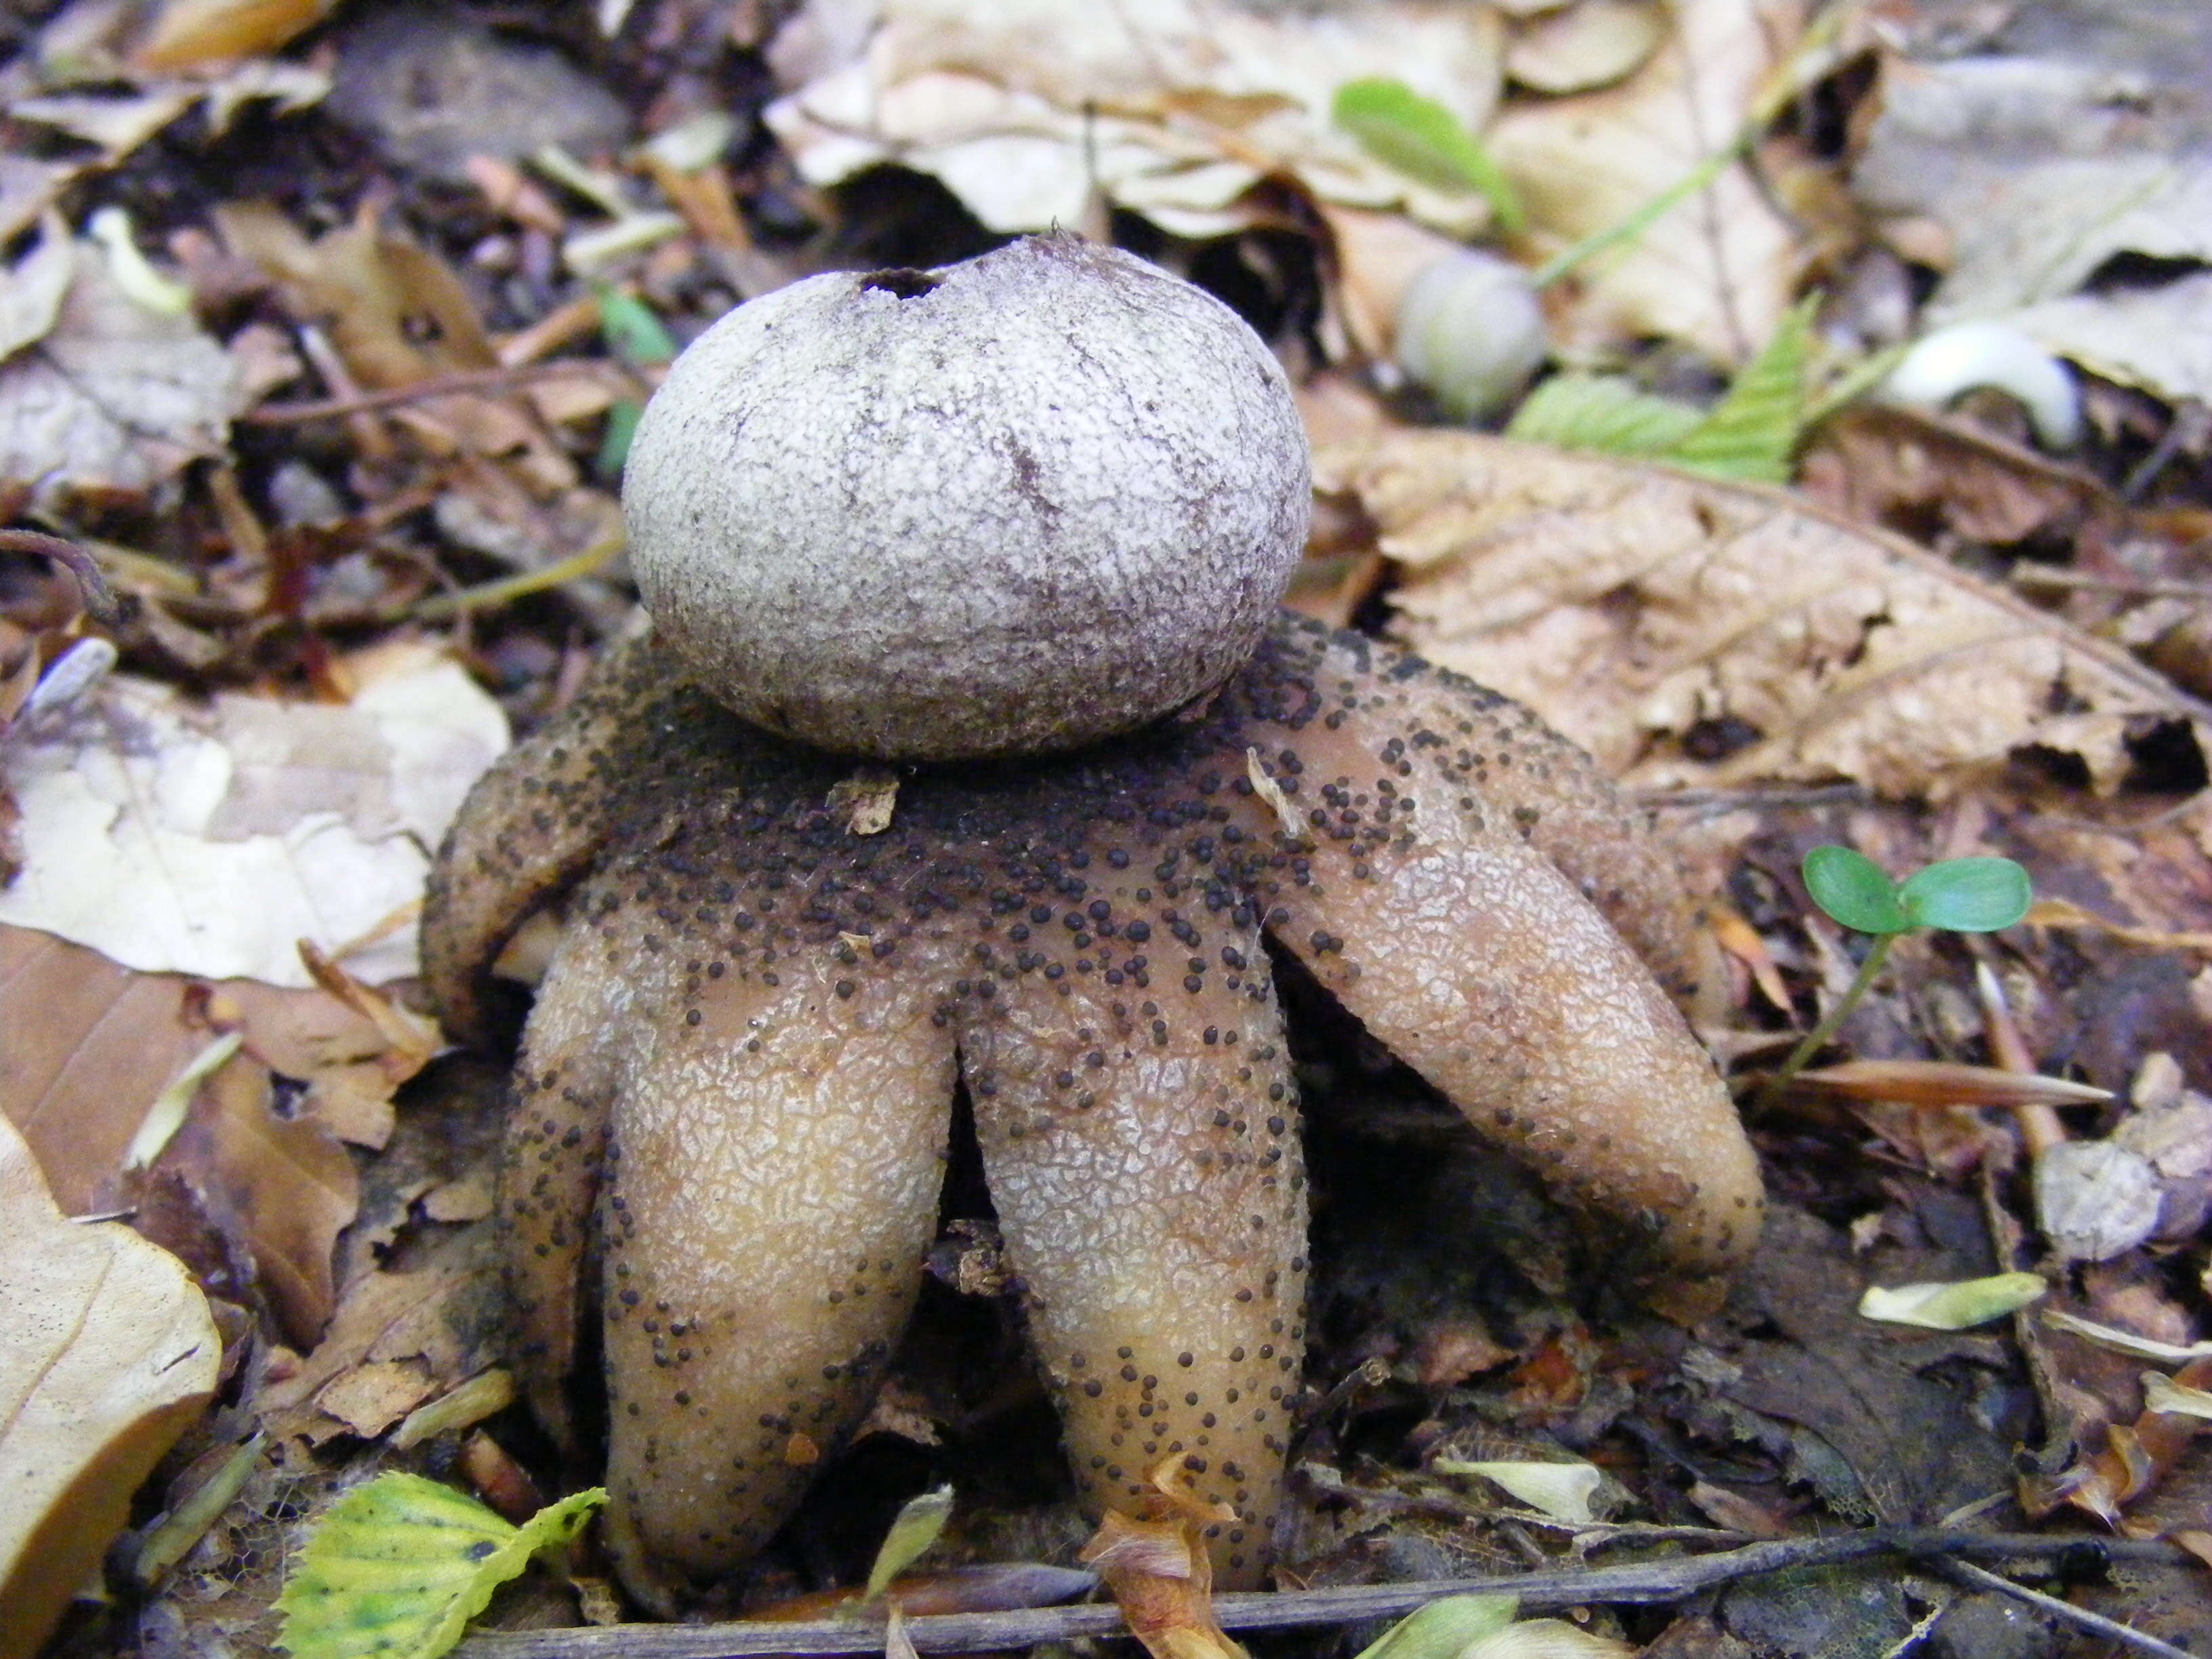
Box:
[960,911,1305,1586]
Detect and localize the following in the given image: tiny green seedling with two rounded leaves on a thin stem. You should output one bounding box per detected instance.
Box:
[1759,847,2035,1106]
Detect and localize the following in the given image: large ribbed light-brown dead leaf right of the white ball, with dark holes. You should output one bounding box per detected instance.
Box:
[1314,431,2212,796]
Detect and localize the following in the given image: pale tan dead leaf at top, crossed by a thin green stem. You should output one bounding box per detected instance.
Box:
[1489,0,1803,363]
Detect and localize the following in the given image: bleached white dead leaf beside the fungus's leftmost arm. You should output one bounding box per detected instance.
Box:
[0,646,506,987]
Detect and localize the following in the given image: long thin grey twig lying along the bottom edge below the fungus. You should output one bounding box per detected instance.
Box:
[455,1526,2190,1659]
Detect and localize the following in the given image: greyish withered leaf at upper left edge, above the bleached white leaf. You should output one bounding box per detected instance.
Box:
[0,241,245,500]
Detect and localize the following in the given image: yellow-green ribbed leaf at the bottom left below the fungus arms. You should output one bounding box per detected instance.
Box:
[276,1473,606,1659]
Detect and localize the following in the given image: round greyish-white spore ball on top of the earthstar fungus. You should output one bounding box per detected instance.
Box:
[621,237,1312,761]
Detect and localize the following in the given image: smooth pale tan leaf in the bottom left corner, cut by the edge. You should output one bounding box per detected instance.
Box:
[0,1124,221,1659]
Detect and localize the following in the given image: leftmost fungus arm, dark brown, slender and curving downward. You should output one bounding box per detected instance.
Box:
[422,635,670,1046]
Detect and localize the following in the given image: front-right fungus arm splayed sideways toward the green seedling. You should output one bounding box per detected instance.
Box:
[1252,684,1761,1274]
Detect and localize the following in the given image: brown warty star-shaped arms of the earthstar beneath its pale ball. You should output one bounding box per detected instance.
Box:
[422,239,1761,1612]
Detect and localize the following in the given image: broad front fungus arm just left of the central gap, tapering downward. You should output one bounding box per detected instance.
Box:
[602,951,954,1612]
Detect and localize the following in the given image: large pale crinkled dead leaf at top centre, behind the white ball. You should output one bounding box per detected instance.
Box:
[768,0,1500,237]
